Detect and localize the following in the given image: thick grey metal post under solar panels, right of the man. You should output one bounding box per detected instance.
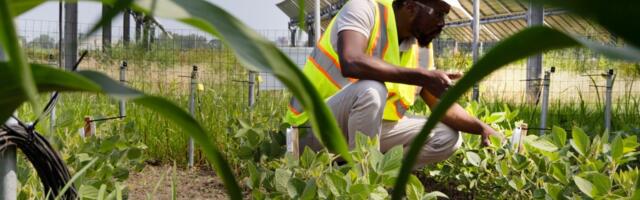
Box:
[526,1,544,102]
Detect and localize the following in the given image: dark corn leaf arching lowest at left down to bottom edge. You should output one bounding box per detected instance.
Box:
[0,63,242,199]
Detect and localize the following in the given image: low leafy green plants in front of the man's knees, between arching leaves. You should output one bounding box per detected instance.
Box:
[238,129,446,199]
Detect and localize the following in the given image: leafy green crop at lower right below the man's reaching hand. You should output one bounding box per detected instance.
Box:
[424,102,640,199]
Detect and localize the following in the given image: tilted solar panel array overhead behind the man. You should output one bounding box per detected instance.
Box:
[277,0,611,42]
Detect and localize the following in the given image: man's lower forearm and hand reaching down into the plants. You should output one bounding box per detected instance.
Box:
[420,89,501,146]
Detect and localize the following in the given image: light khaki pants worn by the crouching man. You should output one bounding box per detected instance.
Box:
[300,80,462,168]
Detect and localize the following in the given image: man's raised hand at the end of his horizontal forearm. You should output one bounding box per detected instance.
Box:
[422,70,462,97]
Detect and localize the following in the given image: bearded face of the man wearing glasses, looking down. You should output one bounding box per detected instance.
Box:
[411,0,451,47]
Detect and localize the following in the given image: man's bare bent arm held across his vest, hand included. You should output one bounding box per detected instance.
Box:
[338,30,461,96]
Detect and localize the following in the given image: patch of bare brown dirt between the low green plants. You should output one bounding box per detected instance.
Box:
[127,165,227,199]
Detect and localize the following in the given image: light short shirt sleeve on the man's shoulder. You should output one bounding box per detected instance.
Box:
[335,0,376,38]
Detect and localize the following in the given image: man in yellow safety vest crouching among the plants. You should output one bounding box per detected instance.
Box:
[286,0,497,167]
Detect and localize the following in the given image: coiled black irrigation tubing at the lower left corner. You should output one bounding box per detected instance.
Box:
[0,124,78,199]
